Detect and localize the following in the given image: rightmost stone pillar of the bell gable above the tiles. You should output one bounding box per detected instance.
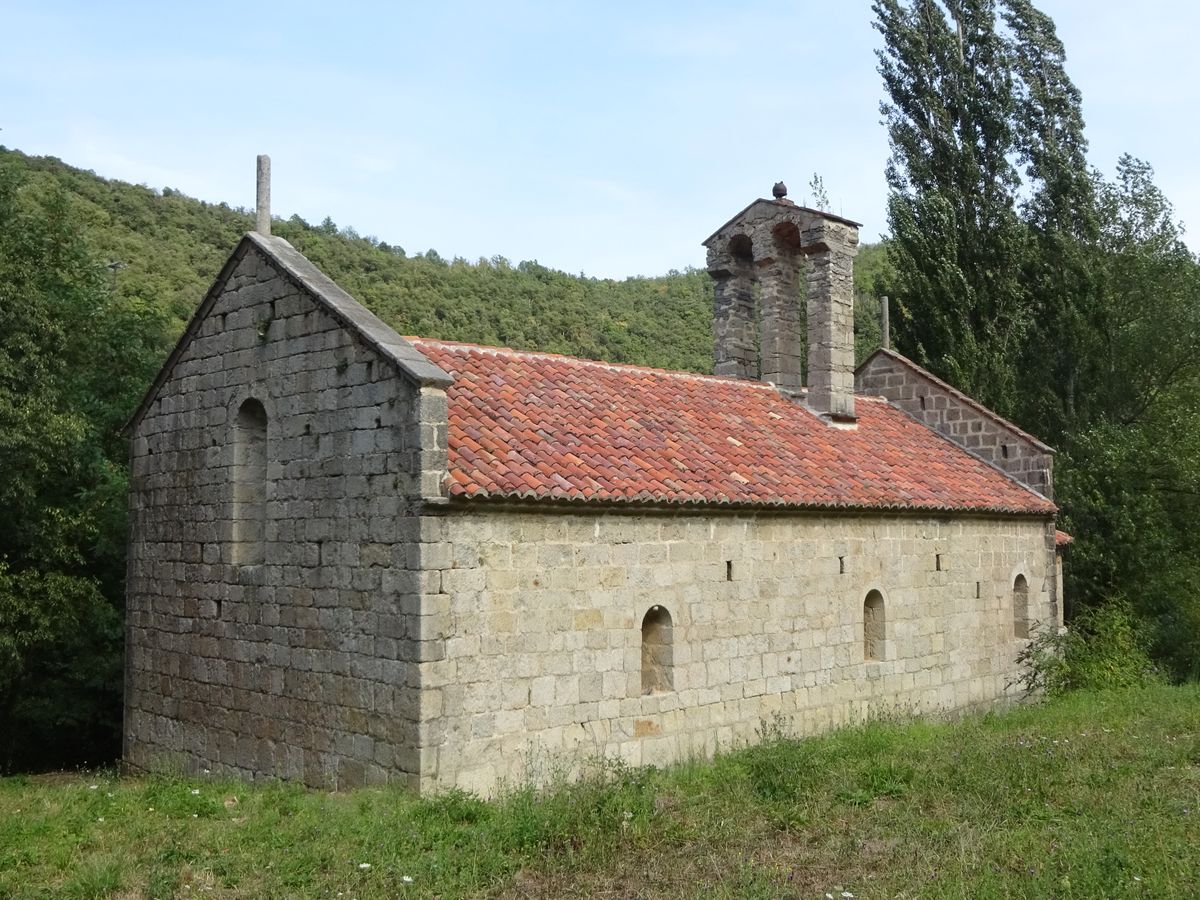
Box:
[804,220,858,420]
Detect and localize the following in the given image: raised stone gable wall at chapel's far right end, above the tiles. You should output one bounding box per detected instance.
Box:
[856,350,1054,499]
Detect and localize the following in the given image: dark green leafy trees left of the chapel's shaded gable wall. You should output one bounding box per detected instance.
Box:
[0,158,168,768]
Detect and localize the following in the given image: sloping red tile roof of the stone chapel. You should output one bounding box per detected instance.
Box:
[409,338,1055,515]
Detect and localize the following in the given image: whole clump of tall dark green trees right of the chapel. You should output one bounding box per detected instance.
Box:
[872,0,1200,677]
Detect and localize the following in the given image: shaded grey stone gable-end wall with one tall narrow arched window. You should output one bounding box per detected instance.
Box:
[125,239,445,786]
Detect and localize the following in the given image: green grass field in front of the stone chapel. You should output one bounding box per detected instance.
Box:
[0,686,1200,900]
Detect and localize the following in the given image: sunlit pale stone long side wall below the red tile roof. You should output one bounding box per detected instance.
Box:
[422,509,1057,792]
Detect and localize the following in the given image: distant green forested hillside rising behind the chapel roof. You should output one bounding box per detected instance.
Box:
[0,146,883,372]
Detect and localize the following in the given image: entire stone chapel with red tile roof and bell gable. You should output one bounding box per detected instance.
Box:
[124,192,1069,794]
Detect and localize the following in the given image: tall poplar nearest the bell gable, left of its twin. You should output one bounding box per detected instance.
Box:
[872,0,1030,412]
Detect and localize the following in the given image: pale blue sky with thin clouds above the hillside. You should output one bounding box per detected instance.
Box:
[0,0,1200,277]
